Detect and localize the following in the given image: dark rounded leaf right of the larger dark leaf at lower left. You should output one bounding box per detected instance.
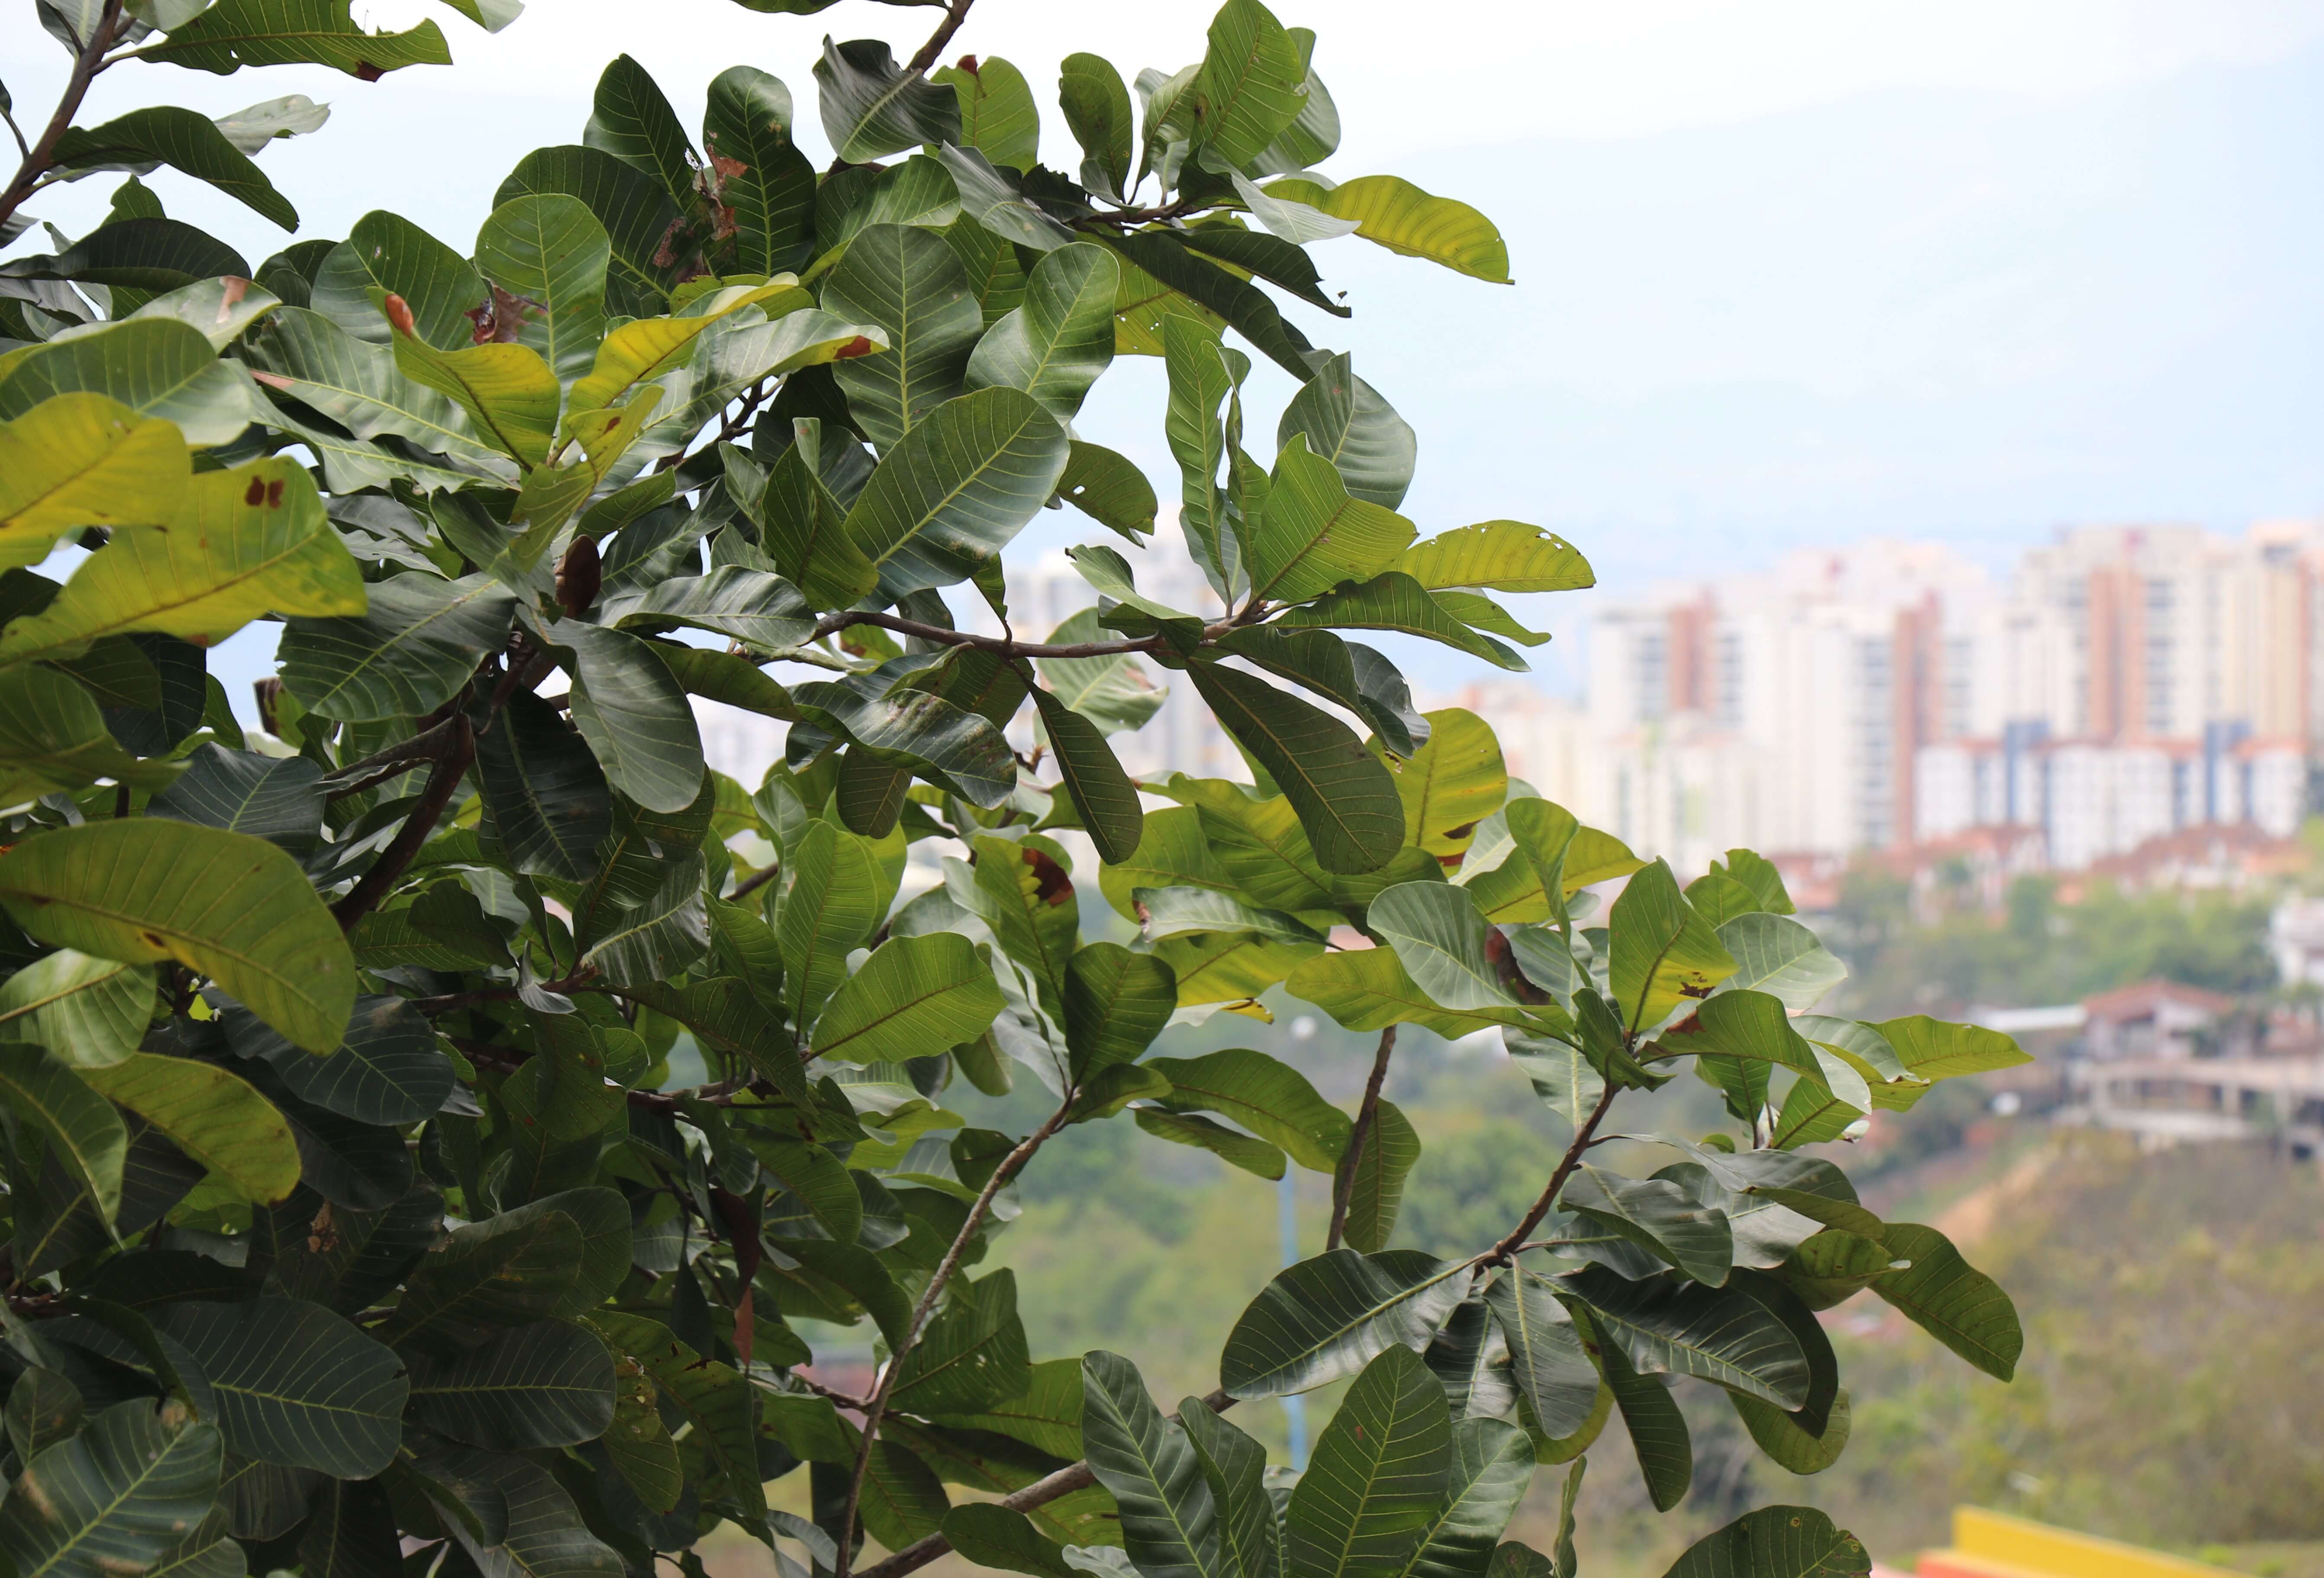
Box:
[411,1320,614,1450]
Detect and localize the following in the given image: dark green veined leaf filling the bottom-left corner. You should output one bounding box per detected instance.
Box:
[0,1397,221,1578]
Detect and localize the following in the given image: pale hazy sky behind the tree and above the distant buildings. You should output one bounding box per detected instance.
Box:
[0,0,2324,683]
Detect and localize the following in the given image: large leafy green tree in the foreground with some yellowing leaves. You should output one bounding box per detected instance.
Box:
[0,0,2019,1578]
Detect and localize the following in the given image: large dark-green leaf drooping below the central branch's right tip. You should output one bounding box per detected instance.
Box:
[1188,662,1404,874]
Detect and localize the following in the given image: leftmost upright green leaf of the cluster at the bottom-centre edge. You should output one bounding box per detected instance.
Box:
[1081,1350,1222,1578]
